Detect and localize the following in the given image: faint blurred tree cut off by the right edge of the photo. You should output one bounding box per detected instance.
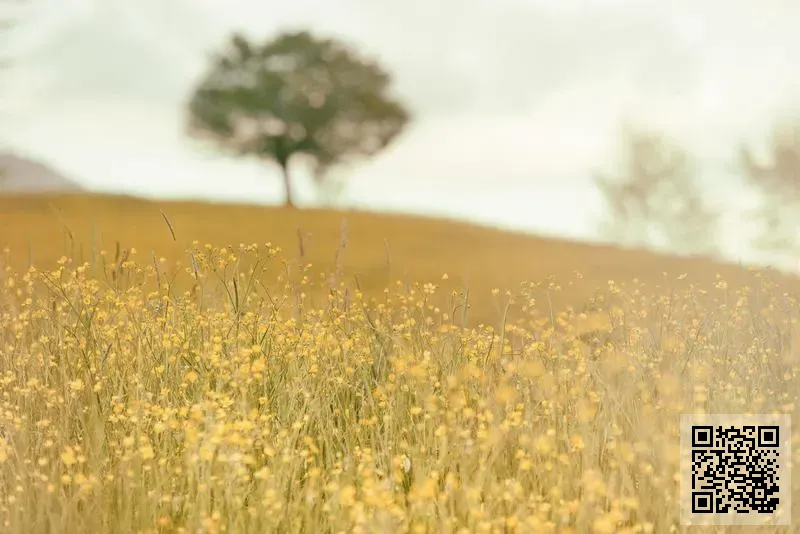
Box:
[739,121,800,254]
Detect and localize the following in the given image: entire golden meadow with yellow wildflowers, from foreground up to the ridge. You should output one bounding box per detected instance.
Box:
[0,196,800,533]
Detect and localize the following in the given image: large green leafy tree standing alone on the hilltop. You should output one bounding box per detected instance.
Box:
[188,32,410,206]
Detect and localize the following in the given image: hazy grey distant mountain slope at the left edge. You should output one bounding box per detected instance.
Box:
[0,152,83,193]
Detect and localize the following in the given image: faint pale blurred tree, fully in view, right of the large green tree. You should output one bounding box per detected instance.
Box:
[595,127,719,255]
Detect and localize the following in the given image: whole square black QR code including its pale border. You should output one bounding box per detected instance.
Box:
[681,415,791,525]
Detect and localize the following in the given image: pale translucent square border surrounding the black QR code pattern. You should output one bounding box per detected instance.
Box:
[680,414,792,526]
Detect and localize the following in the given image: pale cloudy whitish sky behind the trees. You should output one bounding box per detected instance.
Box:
[0,0,800,268]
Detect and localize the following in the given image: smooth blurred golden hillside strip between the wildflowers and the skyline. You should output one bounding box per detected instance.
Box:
[0,194,797,320]
